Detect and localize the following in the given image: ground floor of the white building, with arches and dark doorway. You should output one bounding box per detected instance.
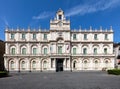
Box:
[4,57,114,71]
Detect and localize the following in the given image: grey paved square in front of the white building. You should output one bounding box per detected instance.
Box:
[0,72,120,89]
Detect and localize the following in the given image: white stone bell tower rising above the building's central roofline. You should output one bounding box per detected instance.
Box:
[50,9,70,30]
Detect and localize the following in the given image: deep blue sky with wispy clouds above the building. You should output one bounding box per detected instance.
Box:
[0,0,120,42]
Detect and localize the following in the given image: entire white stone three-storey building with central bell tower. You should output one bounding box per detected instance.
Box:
[4,9,115,71]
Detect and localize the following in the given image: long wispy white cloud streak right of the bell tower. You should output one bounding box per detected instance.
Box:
[66,0,120,16]
